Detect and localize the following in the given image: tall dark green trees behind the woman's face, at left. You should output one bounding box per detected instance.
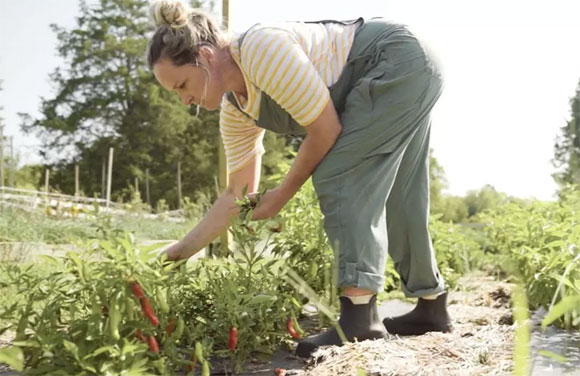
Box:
[21,0,219,206]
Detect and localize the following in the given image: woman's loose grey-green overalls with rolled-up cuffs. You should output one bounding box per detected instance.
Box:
[228,19,444,297]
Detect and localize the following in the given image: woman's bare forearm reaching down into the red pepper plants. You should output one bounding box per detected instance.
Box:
[165,154,262,260]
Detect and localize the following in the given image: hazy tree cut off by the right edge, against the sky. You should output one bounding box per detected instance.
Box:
[552,81,580,187]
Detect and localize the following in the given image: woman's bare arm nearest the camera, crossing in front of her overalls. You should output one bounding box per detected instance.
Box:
[253,100,342,219]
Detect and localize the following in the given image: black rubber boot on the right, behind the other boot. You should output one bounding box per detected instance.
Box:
[383,292,453,336]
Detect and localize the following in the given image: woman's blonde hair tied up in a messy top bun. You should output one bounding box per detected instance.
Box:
[146,0,229,68]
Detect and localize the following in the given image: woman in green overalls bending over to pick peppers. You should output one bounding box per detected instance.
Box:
[147,0,451,356]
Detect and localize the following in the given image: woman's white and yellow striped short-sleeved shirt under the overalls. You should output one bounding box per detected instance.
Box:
[220,22,356,173]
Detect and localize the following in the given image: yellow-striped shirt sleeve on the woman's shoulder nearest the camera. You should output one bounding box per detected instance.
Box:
[241,27,330,126]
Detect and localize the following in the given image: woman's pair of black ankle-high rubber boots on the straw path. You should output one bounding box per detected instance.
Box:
[296,292,452,357]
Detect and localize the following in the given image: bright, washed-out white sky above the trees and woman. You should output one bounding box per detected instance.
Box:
[0,0,580,200]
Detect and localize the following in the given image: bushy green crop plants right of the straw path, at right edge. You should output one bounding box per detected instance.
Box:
[480,186,580,326]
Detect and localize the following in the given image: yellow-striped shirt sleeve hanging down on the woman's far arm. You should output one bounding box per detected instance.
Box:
[220,96,264,174]
